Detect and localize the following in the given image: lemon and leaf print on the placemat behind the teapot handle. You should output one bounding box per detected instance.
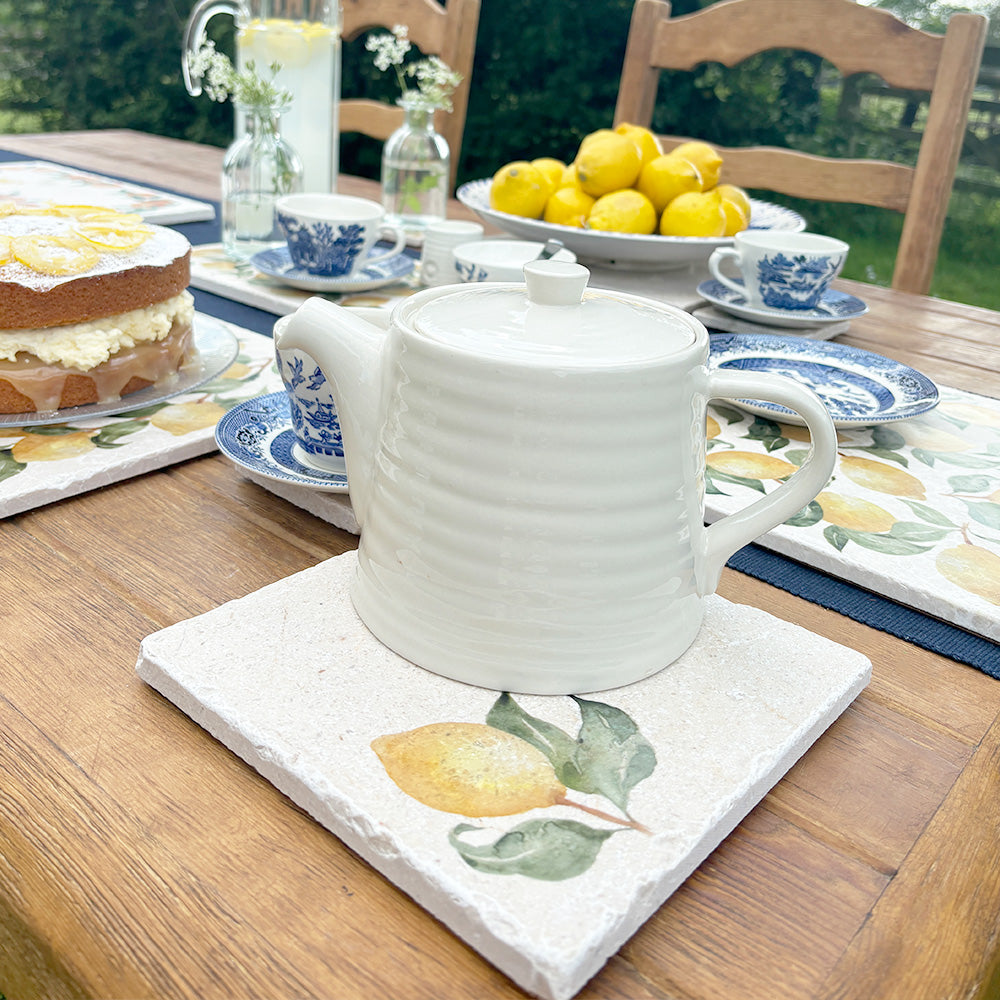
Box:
[705,390,1000,608]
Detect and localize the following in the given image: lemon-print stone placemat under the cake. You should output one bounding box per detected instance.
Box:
[0,313,282,517]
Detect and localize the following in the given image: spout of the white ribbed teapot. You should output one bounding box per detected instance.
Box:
[274,297,389,525]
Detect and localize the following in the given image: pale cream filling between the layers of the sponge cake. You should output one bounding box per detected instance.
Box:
[0,291,194,372]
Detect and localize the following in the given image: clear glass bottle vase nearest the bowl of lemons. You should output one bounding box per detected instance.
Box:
[382,97,451,235]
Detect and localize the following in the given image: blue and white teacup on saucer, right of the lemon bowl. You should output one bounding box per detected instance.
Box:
[708,229,850,310]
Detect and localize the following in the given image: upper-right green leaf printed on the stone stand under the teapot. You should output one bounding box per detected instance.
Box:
[562,695,656,815]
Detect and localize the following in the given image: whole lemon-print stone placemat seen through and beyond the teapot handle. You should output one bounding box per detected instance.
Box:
[705,387,1000,644]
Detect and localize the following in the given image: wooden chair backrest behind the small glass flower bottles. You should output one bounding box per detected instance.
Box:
[340,0,480,188]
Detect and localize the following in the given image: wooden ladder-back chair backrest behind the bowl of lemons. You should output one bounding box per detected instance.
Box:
[615,0,987,294]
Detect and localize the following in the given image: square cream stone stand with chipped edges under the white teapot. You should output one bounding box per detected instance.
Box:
[136,552,871,1000]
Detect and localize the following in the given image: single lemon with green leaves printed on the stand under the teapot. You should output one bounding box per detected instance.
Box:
[371,693,656,882]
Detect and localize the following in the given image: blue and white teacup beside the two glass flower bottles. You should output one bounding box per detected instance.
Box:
[275,194,406,278]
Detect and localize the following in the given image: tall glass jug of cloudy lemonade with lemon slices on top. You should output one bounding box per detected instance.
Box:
[182,0,341,192]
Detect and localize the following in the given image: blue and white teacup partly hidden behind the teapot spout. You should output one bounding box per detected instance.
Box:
[274,307,390,472]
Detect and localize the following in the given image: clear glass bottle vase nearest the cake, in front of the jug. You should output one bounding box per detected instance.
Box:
[222,108,302,263]
